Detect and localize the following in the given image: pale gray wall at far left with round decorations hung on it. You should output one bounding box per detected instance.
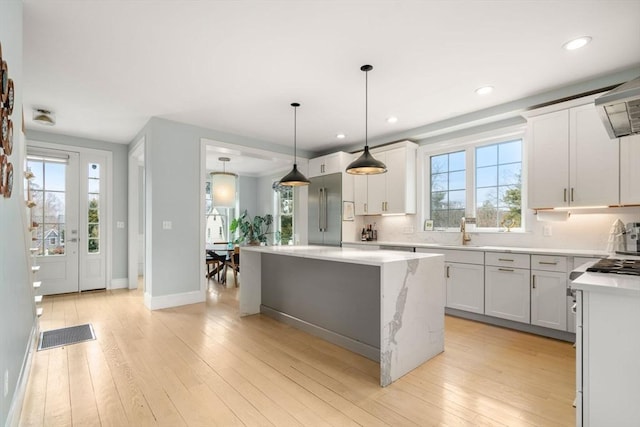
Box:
[0,0,37,425]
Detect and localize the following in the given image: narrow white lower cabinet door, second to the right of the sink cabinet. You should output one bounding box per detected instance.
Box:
[531,270,567,331]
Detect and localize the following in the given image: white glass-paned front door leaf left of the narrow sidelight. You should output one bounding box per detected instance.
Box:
[27,152,79,295]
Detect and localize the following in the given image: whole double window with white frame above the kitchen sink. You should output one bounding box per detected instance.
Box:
[424,134,524,231]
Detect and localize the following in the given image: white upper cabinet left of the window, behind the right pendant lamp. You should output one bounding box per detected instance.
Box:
[354,141,418,215]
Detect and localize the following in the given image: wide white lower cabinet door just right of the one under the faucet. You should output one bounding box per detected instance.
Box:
[484,266,531,323]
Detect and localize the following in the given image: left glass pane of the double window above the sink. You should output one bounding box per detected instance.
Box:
[431,151,466,228]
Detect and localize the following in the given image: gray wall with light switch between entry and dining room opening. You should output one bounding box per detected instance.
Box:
[132,117,310,298]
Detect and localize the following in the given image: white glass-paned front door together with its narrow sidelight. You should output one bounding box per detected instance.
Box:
[27,148,107,295]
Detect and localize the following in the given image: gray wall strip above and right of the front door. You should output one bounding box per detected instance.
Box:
[27,130,129,280]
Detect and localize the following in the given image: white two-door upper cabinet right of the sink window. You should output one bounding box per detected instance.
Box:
[528,103,620,209]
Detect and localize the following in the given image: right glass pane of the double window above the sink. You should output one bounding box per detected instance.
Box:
[475,139,522,228]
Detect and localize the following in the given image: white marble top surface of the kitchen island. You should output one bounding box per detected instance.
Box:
[241,246,438,266]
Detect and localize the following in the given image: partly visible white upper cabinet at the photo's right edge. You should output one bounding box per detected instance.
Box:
[620,135,640,205]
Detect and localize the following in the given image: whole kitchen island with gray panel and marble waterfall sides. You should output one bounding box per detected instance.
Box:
[240,246,445,387]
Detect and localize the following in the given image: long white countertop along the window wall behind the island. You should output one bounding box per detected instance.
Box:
[342,240,610,257]
